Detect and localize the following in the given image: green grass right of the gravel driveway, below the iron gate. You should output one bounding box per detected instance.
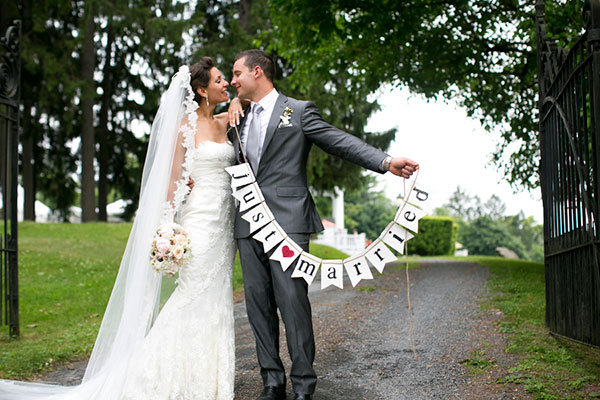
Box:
[455,257,600,399]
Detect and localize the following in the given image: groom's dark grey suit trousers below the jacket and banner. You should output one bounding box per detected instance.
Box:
[237,233,317,394]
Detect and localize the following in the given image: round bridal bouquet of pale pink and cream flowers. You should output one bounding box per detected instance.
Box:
[150,223,191,276]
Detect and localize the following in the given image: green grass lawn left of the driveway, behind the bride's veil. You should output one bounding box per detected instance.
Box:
[0,222,346,379]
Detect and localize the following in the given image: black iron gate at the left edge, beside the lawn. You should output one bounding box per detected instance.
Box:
[0,21,21,337]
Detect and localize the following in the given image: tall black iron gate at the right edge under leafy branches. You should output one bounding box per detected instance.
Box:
[536,0,600,346]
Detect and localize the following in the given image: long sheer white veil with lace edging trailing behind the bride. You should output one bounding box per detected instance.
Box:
[0,66,198,400]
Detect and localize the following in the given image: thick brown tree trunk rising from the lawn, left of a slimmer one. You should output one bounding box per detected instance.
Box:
[81,2,96,222]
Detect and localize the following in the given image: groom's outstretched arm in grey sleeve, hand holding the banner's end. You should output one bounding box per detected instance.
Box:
[302,101,419,178]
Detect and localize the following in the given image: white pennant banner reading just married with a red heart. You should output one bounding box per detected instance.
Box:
[225,163,429,289]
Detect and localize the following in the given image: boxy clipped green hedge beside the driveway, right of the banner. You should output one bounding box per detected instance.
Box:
[407,216,457,256]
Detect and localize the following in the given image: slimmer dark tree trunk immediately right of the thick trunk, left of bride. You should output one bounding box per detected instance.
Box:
[97,21,114,221]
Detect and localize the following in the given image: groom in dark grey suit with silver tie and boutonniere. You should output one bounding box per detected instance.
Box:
[229,50,418,400]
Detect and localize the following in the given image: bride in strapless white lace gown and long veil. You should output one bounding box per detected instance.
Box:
[0,57,244,400]
